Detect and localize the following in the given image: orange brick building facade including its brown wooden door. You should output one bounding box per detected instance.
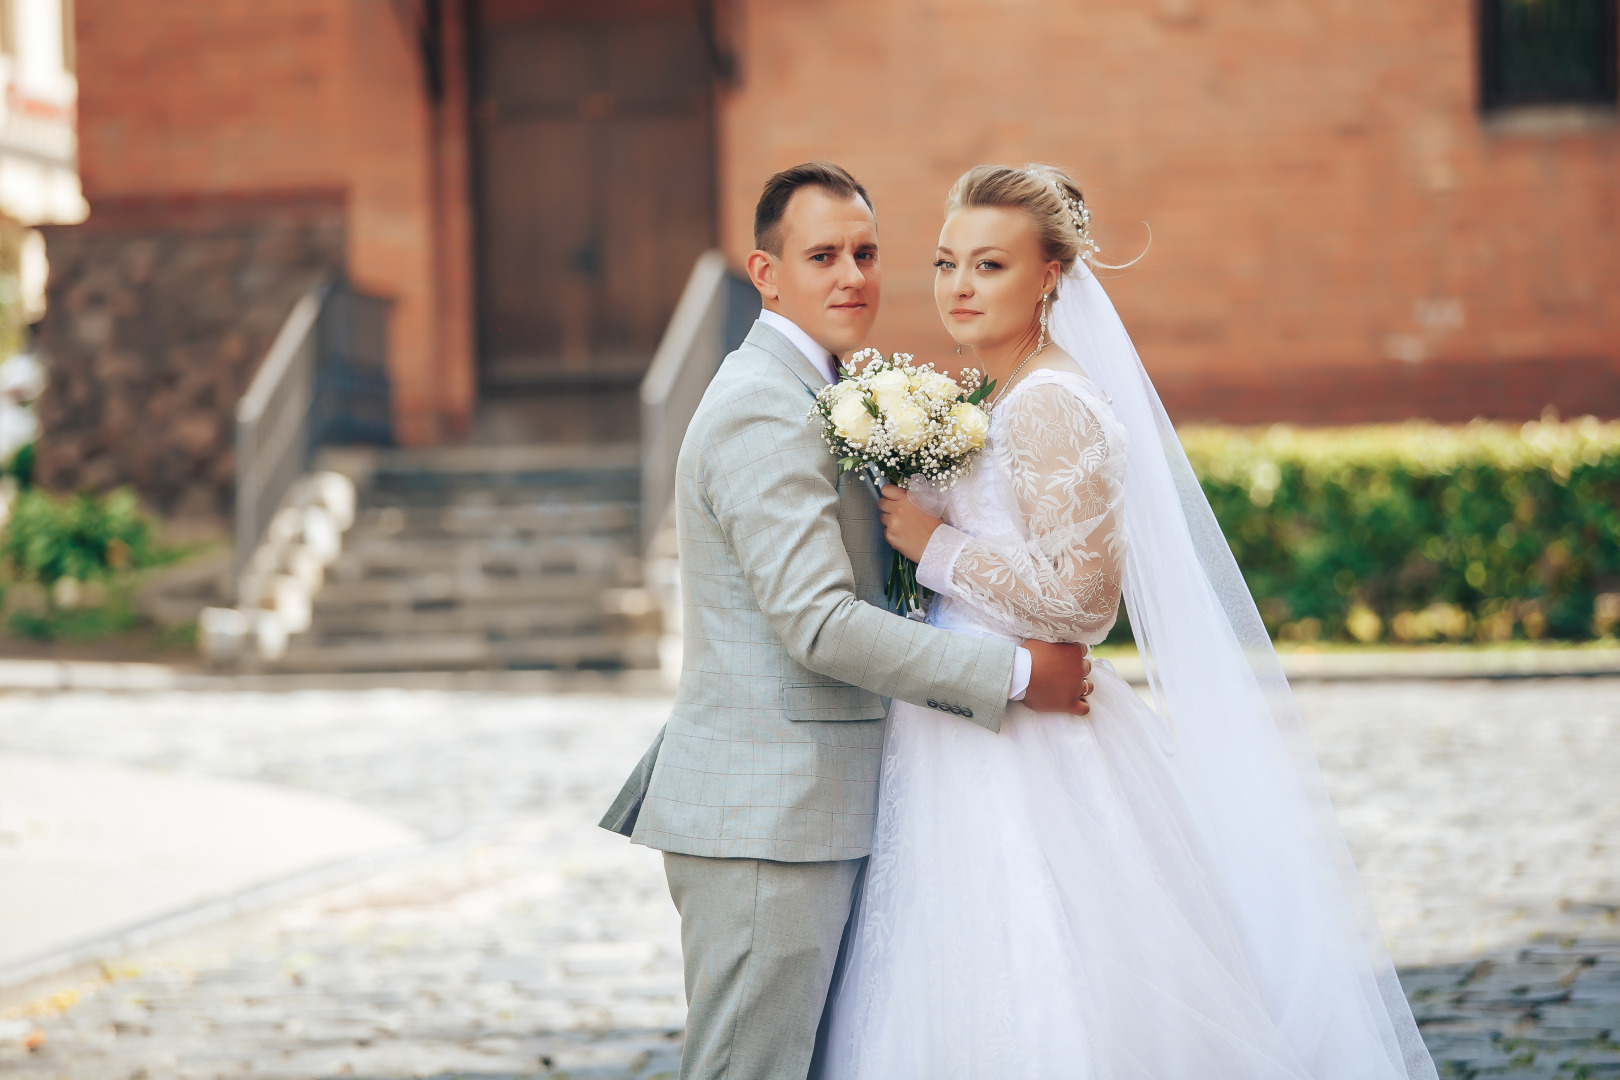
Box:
[31,0,1620,511]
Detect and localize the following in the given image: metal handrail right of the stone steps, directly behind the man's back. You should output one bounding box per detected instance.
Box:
[642,251,760,552]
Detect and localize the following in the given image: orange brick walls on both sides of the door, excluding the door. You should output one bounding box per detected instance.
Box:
[78,0,1620,442]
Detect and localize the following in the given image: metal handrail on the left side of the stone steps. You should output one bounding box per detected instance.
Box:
[233,275,390,576]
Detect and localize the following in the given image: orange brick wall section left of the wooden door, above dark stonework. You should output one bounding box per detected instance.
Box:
[76,0,473,442]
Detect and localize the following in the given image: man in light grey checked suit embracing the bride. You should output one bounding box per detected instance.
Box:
[601,164,1090,1080]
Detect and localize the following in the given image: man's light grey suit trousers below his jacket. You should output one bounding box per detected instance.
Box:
[664,852,867,1080]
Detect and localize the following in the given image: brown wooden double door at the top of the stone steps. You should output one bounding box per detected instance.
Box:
[473,0,716,442]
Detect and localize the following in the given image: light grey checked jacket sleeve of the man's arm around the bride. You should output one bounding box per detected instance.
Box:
[701,387,1016,730]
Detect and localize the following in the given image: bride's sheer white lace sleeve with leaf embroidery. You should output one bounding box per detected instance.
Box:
[919,381,1126,644]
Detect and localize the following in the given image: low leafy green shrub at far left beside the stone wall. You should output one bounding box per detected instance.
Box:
[0,487,164,588]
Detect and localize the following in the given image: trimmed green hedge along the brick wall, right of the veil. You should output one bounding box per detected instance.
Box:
[1181,418,1620,643]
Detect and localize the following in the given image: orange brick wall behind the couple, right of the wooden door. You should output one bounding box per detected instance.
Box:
[721,0,1620,419]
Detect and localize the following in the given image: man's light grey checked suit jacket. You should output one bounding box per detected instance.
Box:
[601,322,1014,861]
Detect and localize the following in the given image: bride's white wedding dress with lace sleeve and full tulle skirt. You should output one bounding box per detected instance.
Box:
[825,369,1432,1080]
